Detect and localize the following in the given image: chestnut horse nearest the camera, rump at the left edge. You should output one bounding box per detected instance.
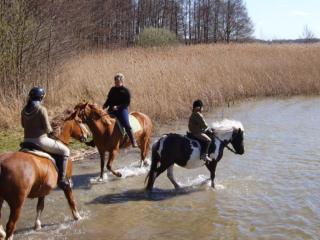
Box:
[0,110,88,239]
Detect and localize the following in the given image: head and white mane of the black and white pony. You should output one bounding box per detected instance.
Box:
[213,119,244,155]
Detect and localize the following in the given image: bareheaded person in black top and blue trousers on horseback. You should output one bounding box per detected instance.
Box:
[103,73,137,147]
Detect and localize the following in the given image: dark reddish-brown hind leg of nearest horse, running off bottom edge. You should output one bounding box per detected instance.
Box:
[6,196,25,240]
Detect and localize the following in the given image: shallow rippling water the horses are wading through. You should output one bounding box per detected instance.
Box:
[3,98,320,240]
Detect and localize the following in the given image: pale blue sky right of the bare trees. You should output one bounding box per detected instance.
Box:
[244,0,320,40]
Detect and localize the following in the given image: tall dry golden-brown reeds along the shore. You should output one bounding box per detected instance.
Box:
[0,44,320,129]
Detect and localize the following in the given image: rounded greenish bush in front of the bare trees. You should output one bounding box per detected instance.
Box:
[136,27,179,47]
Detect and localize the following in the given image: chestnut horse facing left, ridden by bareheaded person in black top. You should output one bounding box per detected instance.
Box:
[75,103,153,179]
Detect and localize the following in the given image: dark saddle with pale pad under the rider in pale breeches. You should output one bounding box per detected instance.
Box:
[19,142,62,173]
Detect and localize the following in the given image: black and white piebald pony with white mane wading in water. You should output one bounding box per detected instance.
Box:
[146,119,244,191]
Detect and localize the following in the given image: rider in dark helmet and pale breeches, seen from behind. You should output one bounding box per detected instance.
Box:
[21,87,70,189]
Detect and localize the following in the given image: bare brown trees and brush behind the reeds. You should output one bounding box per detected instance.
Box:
[0,0,253,96]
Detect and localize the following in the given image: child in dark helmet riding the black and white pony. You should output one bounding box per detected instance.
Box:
[188,99,211,161]
